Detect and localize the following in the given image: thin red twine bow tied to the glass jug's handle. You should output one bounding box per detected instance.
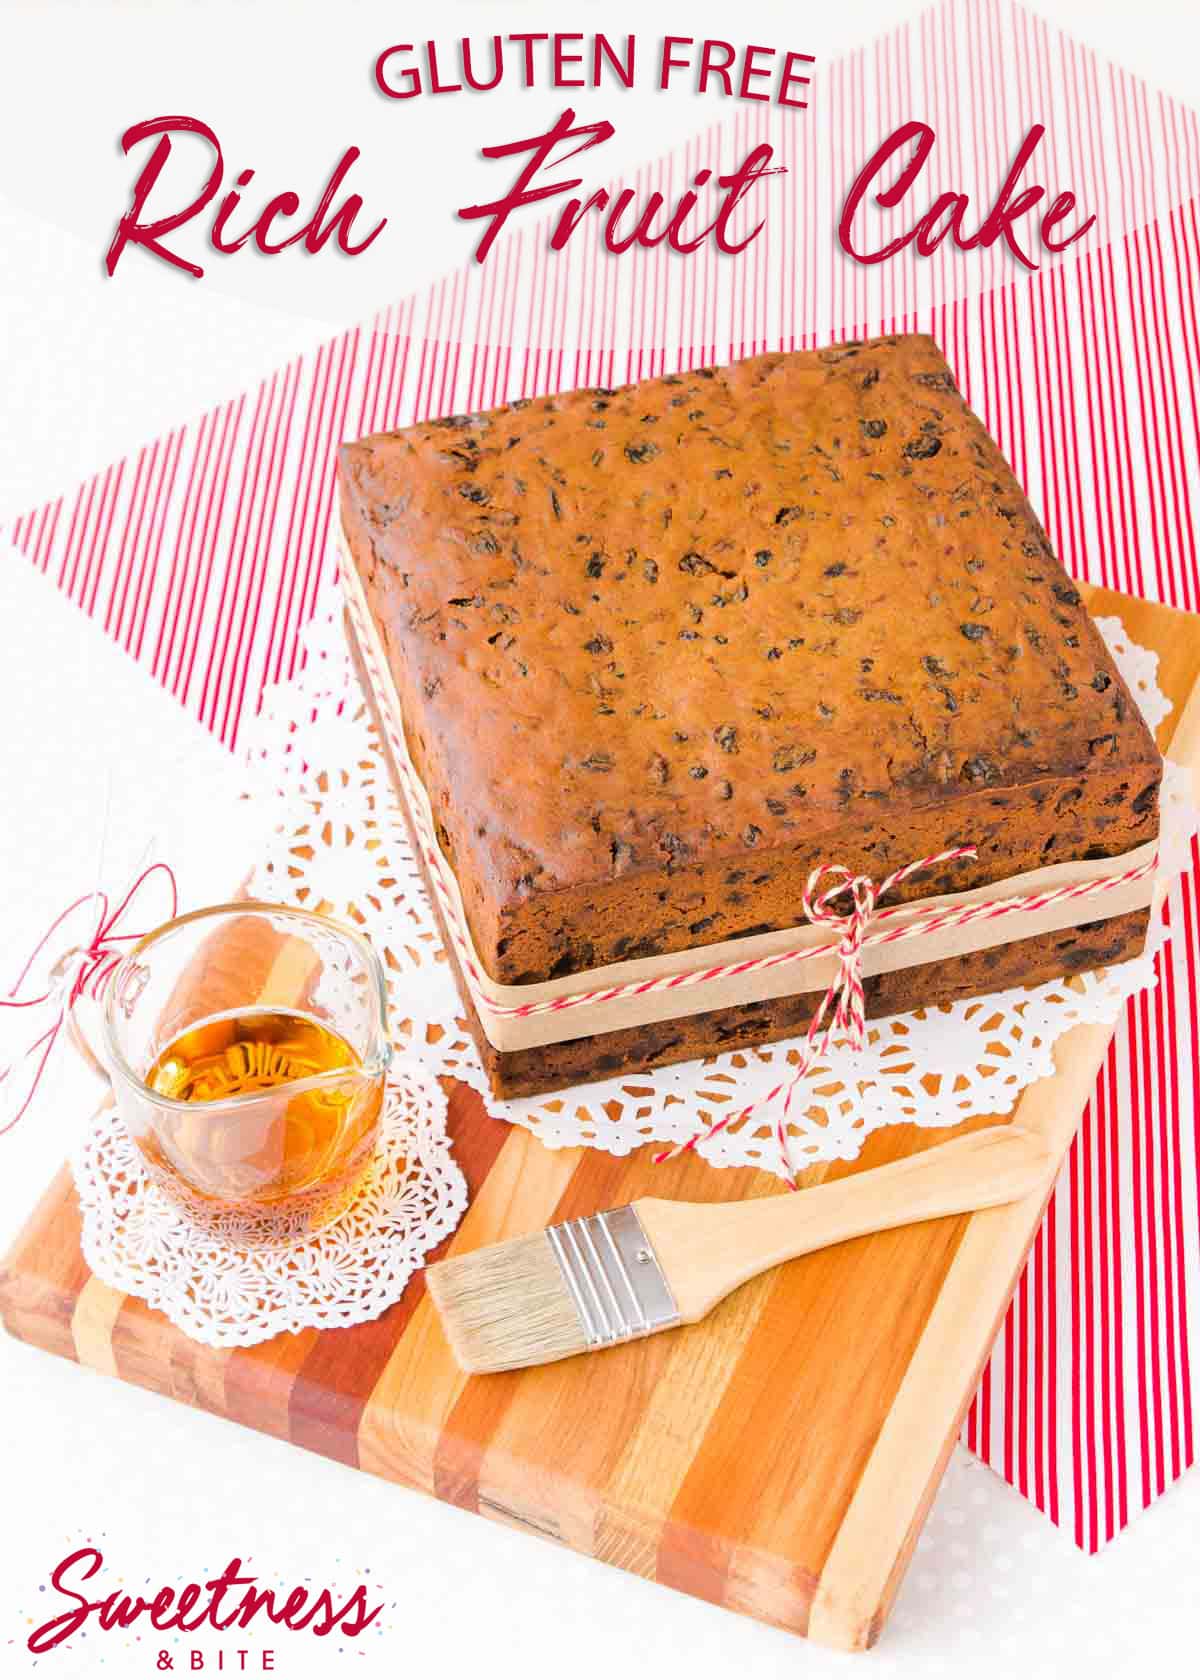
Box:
[0,864,180,1137]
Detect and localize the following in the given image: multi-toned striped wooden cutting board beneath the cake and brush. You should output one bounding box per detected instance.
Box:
[0,590,1200,1650]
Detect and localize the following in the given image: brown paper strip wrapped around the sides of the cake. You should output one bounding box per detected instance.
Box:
[336,524,1158,1052]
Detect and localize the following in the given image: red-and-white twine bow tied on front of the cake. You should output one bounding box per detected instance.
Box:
[654,845,978,1189]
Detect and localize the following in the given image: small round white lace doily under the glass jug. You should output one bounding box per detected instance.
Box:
[71,1062,467,1347]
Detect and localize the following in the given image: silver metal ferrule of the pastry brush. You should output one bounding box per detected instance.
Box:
[546,1208,682,1349]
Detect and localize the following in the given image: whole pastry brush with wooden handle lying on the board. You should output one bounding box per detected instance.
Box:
[425,1126,1054,1371]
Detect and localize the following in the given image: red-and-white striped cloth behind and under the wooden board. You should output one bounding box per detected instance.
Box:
[5,0,1200,1551]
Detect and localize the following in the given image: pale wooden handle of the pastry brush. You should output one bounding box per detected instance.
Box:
[635,1126,1054,1324]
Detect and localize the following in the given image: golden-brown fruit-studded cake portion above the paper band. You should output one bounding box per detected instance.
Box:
[339,336,1161,987]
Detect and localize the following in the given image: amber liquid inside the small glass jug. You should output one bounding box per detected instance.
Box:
[139,1010,383,1226]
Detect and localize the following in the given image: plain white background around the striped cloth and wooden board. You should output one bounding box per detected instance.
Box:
[0,0,1200,1680]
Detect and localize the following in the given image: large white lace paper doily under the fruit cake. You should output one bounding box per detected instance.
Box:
[238,590,1197,1171]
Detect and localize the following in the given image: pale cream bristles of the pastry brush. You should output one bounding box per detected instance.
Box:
[425,1231,588,1371]
